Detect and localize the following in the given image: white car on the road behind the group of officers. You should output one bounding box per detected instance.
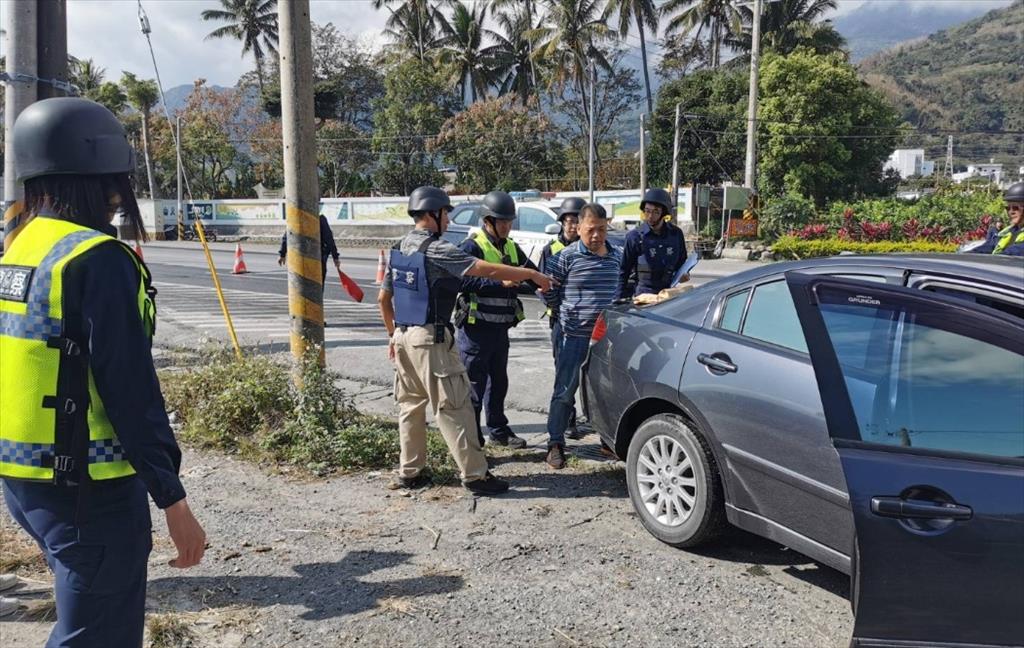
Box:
[443,201,561,263]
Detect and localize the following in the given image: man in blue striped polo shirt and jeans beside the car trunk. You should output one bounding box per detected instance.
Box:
[544,203,623,470]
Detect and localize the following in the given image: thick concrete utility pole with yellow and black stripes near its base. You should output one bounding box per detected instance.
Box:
[278,0,324,366]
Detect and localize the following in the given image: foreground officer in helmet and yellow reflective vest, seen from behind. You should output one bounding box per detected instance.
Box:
[0,97,206,648]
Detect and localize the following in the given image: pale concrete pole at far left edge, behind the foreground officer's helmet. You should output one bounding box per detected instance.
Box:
[3,0,39,249]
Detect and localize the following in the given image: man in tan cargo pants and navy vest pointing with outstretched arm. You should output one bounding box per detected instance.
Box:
[377,186,551,494]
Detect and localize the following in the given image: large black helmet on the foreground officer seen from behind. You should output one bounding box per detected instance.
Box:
[11,97,135,182]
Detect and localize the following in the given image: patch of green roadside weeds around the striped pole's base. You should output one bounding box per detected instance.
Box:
[161,349,456,482]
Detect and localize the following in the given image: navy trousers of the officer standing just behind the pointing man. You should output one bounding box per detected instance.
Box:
[456,323,511,446]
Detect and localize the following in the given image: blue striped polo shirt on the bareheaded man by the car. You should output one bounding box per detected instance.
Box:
[544,241,623,338]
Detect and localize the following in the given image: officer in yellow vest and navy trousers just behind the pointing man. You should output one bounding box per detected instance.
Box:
[455,191,537,448]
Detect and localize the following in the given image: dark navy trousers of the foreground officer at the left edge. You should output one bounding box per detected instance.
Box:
[3,477,153,648]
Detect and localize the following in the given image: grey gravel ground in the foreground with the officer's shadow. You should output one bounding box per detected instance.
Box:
[0,417,852,648]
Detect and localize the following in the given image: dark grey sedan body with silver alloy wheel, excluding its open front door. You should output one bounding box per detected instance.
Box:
[582,255,1024,573]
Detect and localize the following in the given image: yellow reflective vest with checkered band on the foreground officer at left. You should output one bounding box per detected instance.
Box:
[0,216,156,481]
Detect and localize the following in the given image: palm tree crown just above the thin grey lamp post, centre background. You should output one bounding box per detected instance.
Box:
[527,0,611,121]
